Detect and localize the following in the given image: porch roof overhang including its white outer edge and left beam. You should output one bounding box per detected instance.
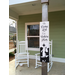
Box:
[9,0,65,19]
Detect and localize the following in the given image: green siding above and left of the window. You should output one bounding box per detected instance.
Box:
[18,14,41,41]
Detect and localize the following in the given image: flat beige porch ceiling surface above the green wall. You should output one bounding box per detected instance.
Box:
[9,0,65,15]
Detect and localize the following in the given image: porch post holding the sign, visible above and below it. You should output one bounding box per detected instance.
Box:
[41,0,49,75]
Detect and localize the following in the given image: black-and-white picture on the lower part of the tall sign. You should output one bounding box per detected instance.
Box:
[40,44,49,62]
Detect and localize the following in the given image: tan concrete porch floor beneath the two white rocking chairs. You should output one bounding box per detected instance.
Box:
[9,59,65,75]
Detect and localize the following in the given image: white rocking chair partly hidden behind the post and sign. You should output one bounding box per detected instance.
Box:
[35,40,53,72]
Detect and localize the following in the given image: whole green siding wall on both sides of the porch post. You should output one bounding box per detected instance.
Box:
[18,11,65,58]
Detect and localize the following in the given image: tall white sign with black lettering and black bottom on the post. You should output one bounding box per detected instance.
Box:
[40,21,49,62]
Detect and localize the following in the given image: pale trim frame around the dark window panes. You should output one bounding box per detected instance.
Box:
[25,22,40,51]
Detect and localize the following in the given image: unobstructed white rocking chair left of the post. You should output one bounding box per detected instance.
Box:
[15,41,29,68]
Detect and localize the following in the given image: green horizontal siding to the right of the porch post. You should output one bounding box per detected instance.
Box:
[49,11,65,58]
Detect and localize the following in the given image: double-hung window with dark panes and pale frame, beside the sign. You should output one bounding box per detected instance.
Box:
[25,23,40,50]
